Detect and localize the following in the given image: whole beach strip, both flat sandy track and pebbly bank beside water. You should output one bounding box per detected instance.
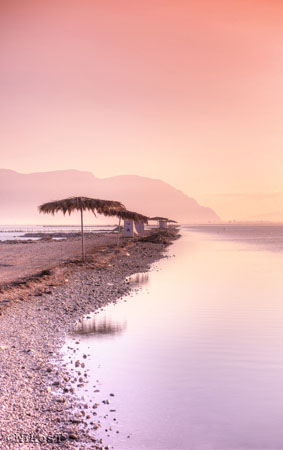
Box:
[0,233,179,449]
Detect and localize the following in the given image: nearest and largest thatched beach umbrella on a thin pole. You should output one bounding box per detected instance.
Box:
[39,197,125,261]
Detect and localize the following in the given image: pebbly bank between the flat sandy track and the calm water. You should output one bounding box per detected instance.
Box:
[0,229,179,450]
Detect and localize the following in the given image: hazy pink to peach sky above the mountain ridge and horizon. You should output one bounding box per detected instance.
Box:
[0,0,283,217]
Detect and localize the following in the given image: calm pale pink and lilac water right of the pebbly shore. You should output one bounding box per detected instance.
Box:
[67,227,283,450]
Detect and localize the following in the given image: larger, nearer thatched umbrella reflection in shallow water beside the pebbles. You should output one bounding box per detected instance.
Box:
[74,314,127,335]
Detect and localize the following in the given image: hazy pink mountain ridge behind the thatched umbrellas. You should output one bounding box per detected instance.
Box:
[0,169,220,224]
